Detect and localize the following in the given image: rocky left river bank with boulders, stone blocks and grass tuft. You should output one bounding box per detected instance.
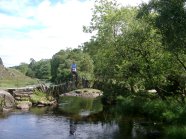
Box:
[0,89,56,111]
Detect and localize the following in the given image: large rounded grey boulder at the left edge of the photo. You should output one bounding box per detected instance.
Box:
[0,90,15,109]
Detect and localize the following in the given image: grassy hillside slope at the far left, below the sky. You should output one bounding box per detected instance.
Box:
[0,65,37,88]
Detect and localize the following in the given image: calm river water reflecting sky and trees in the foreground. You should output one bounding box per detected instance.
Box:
[0,97,166,139]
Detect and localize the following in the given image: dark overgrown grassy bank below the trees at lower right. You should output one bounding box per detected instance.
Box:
[117,96,186,125]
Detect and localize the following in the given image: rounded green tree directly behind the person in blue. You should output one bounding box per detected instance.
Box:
[51,49,93,82]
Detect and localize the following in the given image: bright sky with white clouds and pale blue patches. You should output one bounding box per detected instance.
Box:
[0,0,148,67]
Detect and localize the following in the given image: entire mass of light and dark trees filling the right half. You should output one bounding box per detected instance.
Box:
[83,0,186,100]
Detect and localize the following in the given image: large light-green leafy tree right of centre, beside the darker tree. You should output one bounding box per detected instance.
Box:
[84,0,183,96]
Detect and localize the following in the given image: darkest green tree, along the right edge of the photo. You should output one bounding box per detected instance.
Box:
[138,0,186,102]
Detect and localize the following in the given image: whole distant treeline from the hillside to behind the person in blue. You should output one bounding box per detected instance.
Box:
[14,49,94,83]
